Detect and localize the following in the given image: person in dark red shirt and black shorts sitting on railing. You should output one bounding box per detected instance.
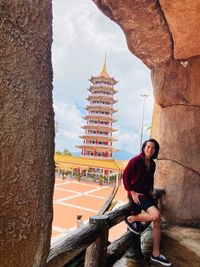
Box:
[123,139,171,266]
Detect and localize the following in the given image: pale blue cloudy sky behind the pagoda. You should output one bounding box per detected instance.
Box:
[52,0,154,154]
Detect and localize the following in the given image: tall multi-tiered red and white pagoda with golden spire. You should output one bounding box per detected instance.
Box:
[77,58,118,160]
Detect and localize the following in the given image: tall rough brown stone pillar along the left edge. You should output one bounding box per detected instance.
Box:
[0,0,54,267]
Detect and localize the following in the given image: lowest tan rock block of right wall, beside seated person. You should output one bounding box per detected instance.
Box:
[155,160,200,226]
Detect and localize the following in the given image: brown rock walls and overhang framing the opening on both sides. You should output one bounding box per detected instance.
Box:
[0,0,200,267]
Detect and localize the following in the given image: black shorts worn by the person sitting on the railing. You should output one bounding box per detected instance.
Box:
[128,195,158,214]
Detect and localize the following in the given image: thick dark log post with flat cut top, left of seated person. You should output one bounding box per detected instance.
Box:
[84,215,109,267]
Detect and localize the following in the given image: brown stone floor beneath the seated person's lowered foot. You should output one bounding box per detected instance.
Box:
[113,227,200,267]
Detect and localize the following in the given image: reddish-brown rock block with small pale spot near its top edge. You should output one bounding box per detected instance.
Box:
[151,57,200,107]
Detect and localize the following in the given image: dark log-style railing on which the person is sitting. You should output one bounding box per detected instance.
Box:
[46,189,164,267]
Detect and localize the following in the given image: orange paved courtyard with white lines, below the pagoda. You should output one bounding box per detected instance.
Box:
[51,177,127,246]
